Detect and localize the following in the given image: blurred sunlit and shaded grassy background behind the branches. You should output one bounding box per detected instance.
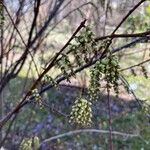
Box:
[0,0,150,150]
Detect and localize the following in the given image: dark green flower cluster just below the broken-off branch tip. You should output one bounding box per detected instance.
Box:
[69,26,98,66]
